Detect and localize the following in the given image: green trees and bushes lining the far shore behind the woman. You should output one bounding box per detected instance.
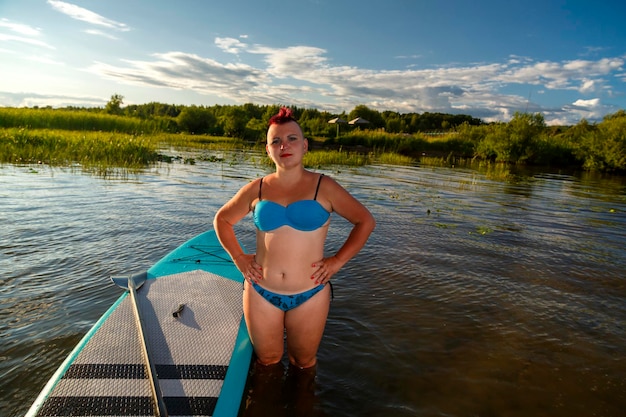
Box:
[0,94,626,172]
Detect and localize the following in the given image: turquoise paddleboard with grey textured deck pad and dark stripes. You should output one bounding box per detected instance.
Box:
[26,230,252,417]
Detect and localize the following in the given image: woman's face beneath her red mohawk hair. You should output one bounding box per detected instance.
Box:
[265,122,309,165]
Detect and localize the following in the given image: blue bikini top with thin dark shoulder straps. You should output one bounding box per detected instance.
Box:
[252,174,330,232]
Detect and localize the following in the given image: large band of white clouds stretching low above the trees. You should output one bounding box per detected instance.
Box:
[13,33,626,124]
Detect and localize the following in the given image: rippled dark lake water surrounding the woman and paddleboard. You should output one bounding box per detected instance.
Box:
[0,154,626,417]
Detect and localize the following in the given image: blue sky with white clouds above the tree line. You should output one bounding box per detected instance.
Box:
[0,0,626,124]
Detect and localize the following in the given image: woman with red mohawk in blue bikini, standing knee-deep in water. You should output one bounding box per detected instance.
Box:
[213,108,375,369]
